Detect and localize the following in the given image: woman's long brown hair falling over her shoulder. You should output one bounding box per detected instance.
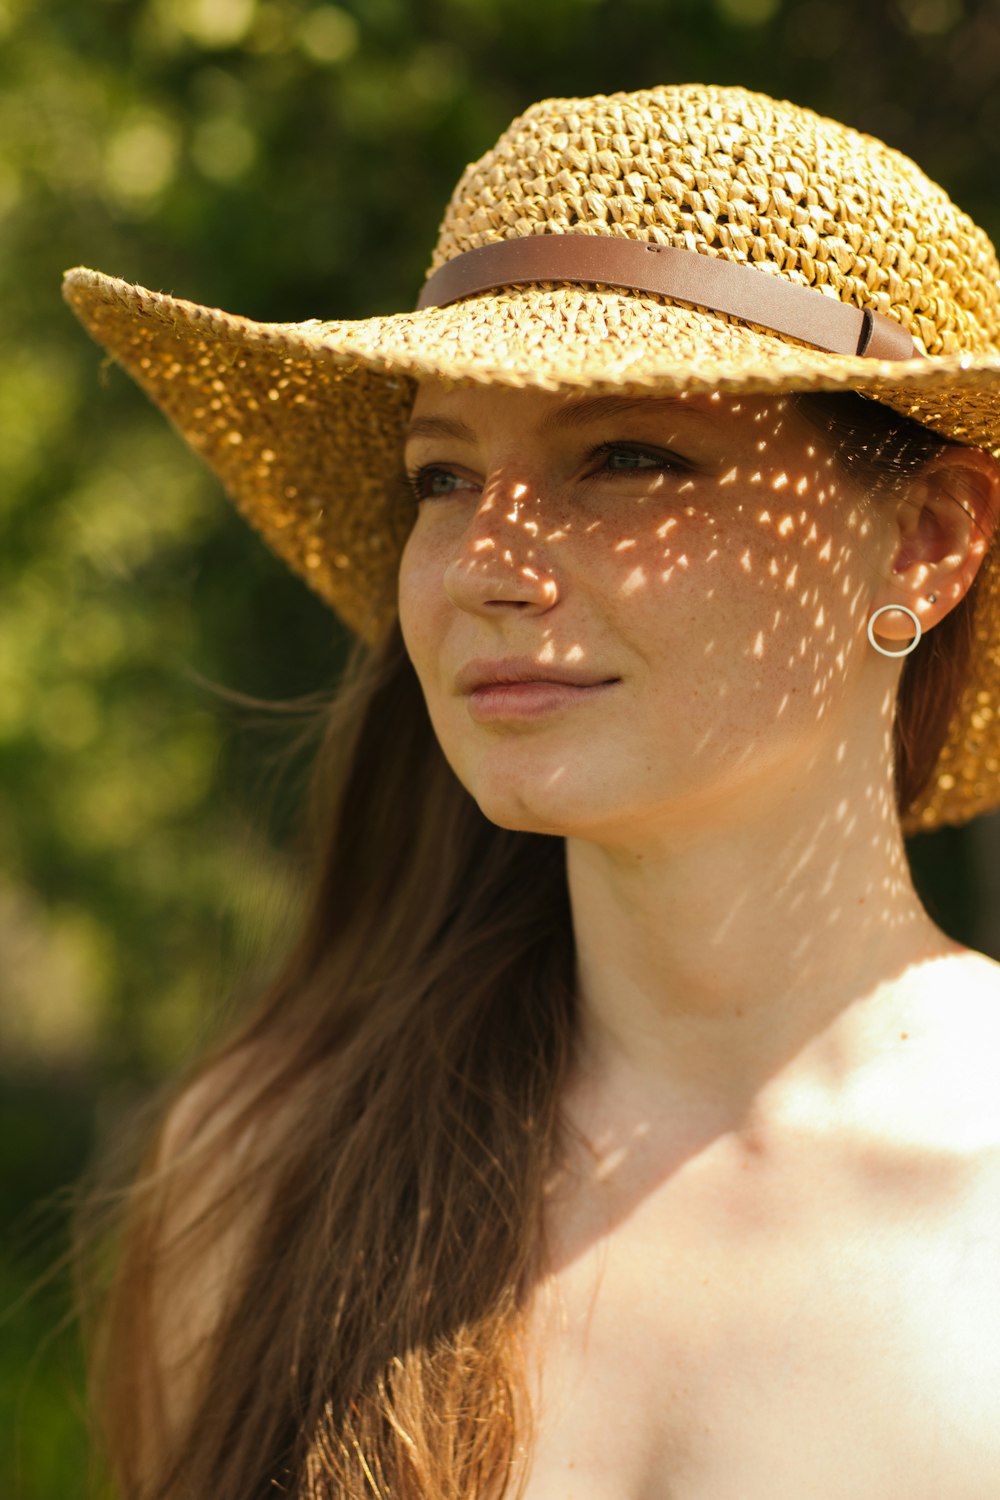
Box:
[78,395,995,1500]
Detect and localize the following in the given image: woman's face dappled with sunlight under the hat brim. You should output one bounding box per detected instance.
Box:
[399,383,893,839]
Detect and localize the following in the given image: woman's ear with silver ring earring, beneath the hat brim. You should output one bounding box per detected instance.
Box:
[871,444,1000,639]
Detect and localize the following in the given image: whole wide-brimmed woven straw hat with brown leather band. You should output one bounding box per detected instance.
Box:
[64,86,1000,831]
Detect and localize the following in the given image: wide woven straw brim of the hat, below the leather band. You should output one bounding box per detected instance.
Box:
[63,267,1000,833]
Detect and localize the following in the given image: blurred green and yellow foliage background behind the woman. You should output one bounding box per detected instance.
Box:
[0,0,1000,1500]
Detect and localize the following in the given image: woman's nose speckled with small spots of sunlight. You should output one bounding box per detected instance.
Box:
[444,479,561,615]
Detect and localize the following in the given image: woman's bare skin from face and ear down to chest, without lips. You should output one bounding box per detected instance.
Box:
[399,384,1000,1500]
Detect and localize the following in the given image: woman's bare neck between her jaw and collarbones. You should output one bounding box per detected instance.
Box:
[567,750,966,1118]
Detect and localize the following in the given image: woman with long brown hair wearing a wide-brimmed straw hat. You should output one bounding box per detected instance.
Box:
[67,87,1000,1500]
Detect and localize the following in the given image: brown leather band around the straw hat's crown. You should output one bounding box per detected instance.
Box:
[417,234,921,360]
